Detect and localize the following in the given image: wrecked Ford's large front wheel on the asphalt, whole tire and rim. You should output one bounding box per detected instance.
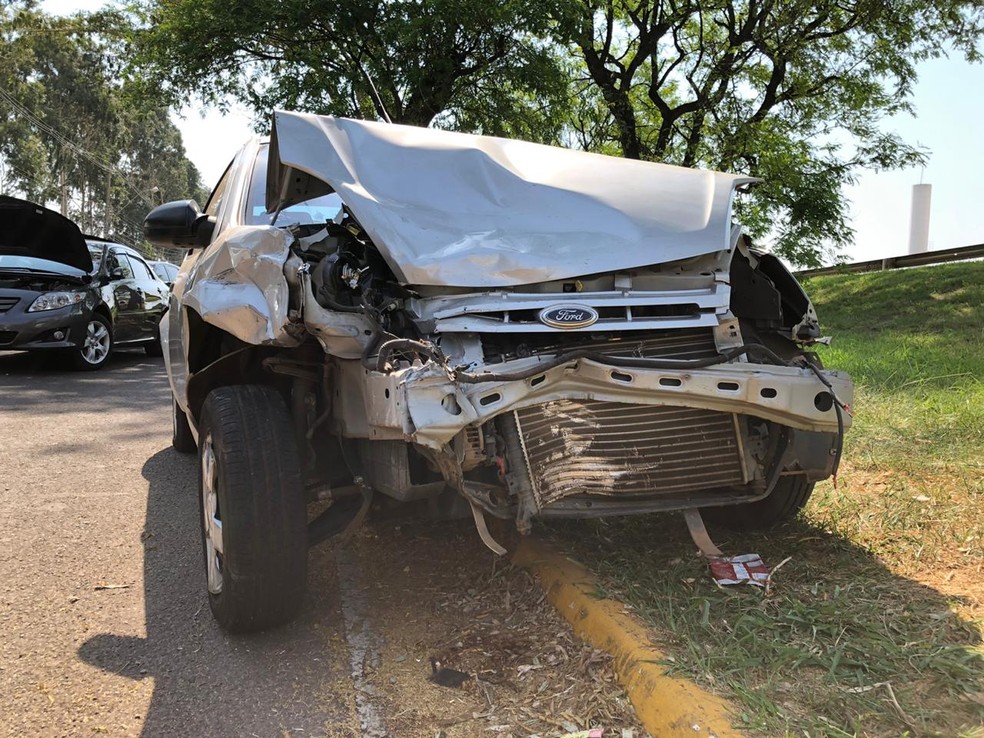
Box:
[198,385,308,633]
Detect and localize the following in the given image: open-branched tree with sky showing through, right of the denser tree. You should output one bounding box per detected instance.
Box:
[555,0,984,266]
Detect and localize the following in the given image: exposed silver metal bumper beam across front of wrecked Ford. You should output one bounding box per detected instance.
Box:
[352,359,854,449]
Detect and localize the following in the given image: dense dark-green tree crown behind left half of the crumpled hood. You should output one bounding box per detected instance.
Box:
[128,0,566,140]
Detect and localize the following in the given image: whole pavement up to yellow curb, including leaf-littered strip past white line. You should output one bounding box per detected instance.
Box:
[0,351,642,738]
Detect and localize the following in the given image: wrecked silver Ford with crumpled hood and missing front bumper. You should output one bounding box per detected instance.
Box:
[144,112,853,631]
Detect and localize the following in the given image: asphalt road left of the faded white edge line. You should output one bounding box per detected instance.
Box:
[0,351,358,736]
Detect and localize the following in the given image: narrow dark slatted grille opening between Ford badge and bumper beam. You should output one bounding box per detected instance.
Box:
[482,329,717,363]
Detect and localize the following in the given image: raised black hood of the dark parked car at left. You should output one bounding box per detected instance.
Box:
[0,195,92,273]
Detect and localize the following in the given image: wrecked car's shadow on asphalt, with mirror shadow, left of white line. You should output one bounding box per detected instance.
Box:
[79,446,350,736]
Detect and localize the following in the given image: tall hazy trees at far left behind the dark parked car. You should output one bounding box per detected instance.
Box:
[0,2,203,252]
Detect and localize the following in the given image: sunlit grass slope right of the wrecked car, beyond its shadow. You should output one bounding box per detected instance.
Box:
[804,262,984,578]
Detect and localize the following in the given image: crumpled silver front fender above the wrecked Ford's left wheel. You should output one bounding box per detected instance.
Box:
[181,227,299,346]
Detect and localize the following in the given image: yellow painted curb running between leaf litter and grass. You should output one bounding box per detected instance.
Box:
[513,538,741,738]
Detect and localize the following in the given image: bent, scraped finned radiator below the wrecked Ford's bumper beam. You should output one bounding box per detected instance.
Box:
[515,400,745,509]
